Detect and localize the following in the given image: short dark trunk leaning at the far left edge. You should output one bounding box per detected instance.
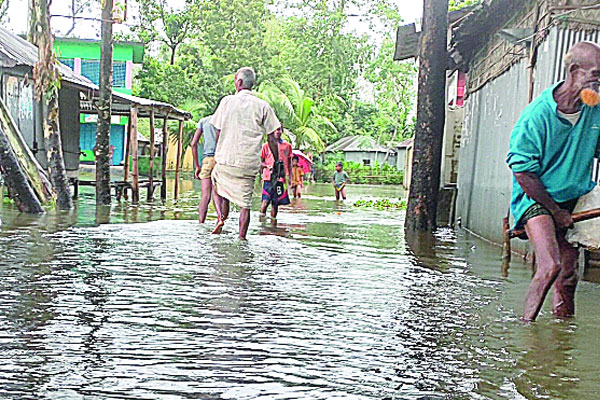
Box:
[0,126,44,214]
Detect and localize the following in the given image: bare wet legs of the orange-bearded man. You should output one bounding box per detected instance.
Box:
[522,215,578,321]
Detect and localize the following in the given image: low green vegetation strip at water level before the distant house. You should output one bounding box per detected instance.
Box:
[315,153,404,185]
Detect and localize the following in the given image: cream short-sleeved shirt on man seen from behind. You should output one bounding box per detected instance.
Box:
[210,89,281,172]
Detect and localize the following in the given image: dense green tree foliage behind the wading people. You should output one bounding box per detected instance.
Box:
[129,0,416,151]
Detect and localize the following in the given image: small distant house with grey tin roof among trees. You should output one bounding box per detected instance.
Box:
[325,136,396,167]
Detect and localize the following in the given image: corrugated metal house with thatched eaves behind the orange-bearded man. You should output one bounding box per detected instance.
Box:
[397,0,600,251]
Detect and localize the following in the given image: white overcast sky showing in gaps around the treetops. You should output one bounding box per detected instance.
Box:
[4,0,423,39]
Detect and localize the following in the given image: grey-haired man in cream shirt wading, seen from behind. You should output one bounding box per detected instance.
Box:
[211,67,281,239]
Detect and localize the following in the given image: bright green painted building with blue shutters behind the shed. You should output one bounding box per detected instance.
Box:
[54,38,144,165]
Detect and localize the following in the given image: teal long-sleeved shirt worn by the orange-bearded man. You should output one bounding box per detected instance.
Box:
[506,82,600,225]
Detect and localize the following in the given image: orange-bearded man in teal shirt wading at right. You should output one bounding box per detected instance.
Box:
[507,42,600,321]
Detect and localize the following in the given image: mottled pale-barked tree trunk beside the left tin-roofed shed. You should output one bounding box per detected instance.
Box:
[29,0,73,210]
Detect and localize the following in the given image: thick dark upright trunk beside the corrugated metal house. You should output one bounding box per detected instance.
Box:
[405,0,448,232]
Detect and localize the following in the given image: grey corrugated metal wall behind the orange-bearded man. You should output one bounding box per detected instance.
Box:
[456,28,600,250]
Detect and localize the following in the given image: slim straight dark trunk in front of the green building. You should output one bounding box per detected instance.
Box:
[95,0,113,205]
